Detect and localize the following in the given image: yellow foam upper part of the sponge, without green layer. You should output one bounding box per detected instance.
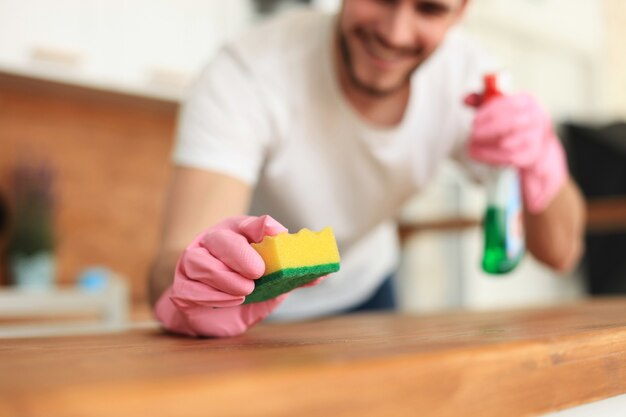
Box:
[252,227,339,275]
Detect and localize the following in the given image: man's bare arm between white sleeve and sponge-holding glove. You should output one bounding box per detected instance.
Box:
[148,167,251,306]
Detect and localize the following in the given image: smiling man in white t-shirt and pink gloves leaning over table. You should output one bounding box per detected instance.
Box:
[150,0,583,336]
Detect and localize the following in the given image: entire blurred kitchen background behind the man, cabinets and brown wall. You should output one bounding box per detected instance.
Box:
[0,0,626,336]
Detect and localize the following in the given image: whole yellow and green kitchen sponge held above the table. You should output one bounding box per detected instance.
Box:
[244,227,340,304]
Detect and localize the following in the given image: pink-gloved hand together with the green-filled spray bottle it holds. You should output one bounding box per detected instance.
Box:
[465,74,568,274]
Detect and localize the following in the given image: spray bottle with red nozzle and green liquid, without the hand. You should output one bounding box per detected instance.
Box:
[481,74,525,274]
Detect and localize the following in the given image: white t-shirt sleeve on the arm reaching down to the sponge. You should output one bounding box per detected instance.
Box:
[172,47,272,185]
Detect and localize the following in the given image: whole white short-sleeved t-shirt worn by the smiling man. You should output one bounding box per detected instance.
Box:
[173,10,493,319]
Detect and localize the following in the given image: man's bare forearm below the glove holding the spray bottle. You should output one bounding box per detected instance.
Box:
[524,178,585,272]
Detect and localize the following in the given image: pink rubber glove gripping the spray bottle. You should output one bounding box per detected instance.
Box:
[465,94,568,213]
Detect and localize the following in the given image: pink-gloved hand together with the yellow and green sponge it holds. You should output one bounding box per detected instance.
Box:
[155,216,339,337]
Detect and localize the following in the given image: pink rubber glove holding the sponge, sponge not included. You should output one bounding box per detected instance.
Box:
[155,216,287,337]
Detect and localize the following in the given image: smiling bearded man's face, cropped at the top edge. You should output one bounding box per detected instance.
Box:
[339,0,466,96]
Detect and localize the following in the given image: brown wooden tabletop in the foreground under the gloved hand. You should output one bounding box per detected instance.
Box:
[0,299,626,417]
